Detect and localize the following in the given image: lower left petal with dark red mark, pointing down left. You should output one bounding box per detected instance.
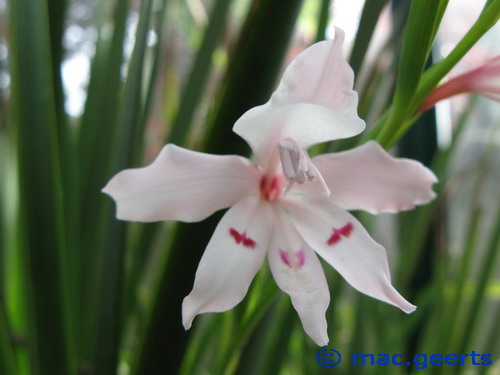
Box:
[182,197,273,329]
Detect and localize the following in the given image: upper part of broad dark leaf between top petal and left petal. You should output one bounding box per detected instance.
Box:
[204,0,302,154]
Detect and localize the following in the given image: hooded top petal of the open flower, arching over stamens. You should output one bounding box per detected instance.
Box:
[233,29,365,159]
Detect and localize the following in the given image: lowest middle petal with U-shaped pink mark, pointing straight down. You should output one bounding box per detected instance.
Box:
[268,206,330,346]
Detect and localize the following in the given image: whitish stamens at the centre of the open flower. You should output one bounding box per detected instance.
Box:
[278,138,331,197]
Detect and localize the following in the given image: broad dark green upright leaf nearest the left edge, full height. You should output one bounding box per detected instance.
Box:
[10,0,76,375]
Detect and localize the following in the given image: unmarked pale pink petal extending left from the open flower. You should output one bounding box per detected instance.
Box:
[102,144,260,222]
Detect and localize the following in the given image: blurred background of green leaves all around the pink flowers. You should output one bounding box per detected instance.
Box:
[0,0,500,375]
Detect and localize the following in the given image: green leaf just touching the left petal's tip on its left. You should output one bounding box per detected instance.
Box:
[74,0,129,363]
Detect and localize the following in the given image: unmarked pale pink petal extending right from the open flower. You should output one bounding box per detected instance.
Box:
[303,141,437,214]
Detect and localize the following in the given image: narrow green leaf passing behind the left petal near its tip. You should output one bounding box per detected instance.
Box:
[95,0,153,375]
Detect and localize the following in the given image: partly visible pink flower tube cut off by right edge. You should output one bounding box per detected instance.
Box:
[420,56,500,112]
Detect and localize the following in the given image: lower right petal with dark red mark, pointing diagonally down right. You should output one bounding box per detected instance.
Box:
[284,196,415,313]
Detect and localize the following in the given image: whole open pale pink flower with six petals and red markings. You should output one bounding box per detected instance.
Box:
[103,29,436,345]
